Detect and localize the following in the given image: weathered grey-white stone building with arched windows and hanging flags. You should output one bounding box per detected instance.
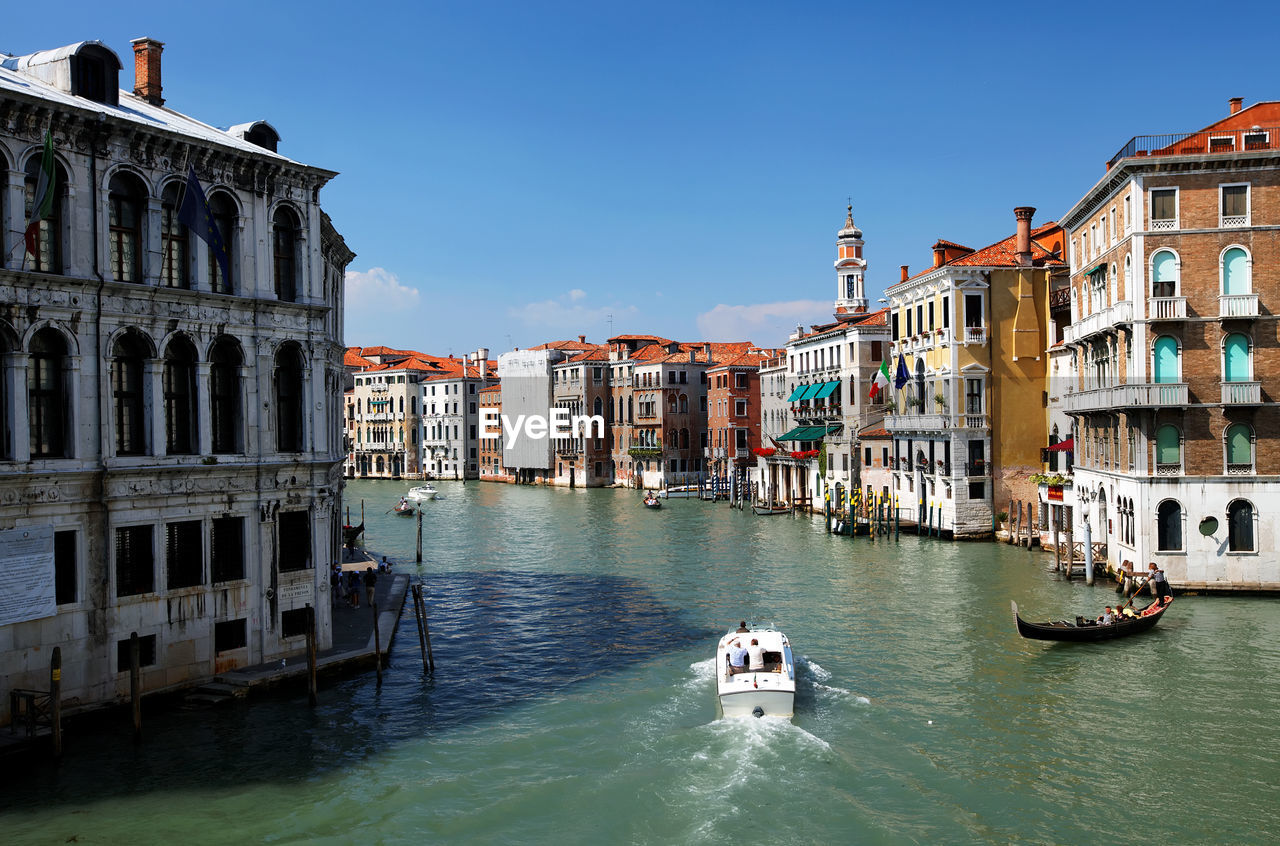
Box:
[0,38,353,723]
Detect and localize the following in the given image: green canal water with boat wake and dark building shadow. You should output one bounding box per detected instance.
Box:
[0,483,1280,845]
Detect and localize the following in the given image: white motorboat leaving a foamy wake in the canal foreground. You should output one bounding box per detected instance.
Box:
[716,628,796,717]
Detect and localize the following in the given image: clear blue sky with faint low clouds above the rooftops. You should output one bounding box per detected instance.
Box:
[0,0,1280,355]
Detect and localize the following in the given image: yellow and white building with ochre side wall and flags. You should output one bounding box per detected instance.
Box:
[882,207,1066,538]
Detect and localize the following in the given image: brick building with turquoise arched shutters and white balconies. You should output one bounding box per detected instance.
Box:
[1062,99,1280,589]
